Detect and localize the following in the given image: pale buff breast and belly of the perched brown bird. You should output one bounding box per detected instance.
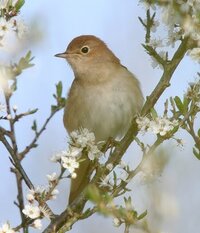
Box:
[64,81,136,141]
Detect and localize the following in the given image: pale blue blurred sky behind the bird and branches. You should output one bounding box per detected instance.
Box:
[0,0,200,233]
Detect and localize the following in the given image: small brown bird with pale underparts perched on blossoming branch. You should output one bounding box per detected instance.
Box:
[55,35,144,204]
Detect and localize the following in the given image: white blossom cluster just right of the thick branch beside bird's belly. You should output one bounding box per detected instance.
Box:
[136,116,178,136]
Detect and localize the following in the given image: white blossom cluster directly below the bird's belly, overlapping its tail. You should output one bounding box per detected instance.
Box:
[51,128,102,178]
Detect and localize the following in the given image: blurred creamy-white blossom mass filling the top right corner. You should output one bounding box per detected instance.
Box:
[140,0,200,62]
